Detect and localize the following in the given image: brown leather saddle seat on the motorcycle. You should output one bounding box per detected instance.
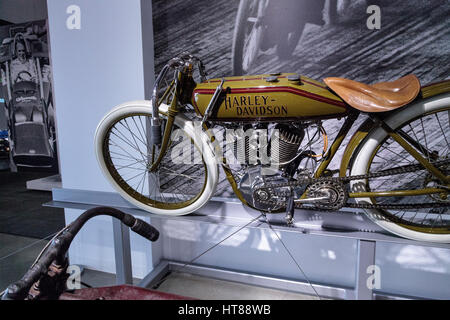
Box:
[324,74,420,112]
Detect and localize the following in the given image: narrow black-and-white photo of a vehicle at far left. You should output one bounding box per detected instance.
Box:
[0,20,57,171]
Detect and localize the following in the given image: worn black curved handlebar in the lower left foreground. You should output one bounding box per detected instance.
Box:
[2,207,159,300]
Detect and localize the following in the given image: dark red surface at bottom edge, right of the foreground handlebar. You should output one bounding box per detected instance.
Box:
[59,285,194,300]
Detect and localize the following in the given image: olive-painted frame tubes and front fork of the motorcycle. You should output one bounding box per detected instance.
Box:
[149,69,450,212]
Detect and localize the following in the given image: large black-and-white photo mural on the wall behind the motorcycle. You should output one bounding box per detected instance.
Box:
[152,0,450,195]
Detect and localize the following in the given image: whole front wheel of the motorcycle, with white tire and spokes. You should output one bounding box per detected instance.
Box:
[95,101,218,215]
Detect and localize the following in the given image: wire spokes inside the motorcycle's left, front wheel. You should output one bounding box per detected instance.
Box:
[104,115,206,208]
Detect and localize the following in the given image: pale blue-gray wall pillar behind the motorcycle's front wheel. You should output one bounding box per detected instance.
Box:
[48,0,153,276]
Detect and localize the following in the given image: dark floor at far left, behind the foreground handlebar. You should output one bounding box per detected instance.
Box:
[0,170,65,291]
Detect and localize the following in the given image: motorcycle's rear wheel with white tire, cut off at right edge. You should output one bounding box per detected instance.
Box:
[350,94,450,243]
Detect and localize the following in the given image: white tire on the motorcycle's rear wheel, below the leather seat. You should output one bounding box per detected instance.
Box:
[350,94,450,243]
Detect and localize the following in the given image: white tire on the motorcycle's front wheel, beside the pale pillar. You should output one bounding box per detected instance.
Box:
[94,101,219,215]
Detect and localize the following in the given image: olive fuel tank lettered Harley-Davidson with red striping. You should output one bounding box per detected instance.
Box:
[192,73,348,121]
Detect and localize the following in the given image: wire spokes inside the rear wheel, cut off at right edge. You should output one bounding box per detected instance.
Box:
[367,111,450,232]
